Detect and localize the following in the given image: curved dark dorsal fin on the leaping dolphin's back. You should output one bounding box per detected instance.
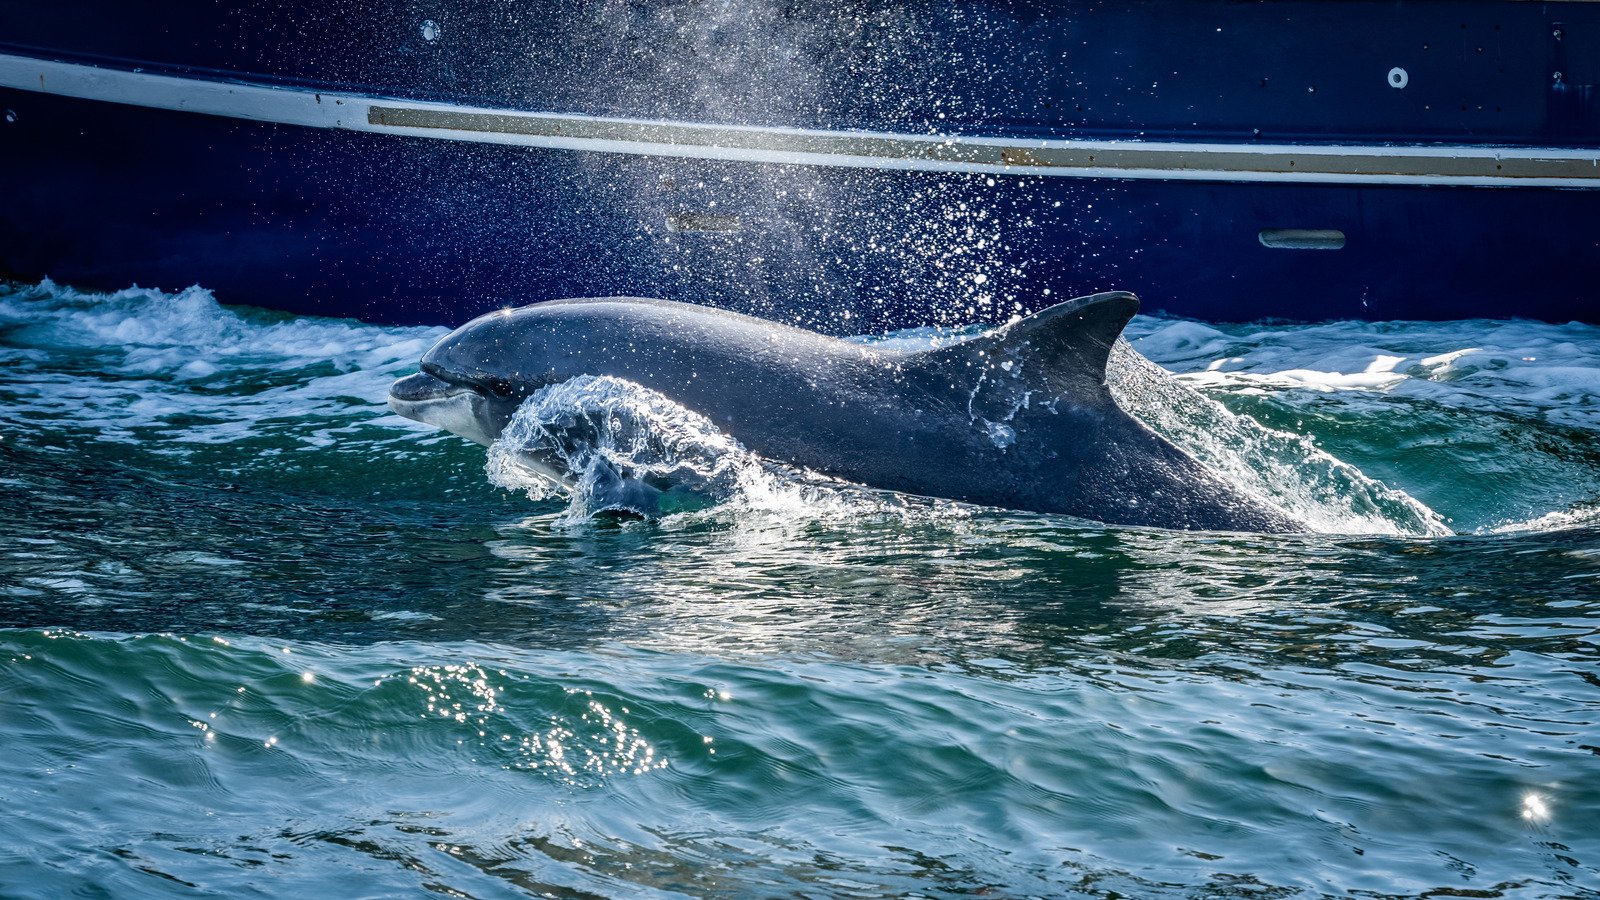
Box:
[922,291,1139,388]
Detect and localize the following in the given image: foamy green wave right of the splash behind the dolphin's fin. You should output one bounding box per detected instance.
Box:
[1128,317,1600,532]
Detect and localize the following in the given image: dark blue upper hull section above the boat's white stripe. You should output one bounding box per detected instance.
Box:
[12,0,1600,147]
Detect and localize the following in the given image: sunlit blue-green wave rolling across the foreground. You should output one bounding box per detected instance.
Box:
[0,627,1597,897]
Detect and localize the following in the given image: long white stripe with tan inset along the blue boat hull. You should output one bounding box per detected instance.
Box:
[0,54,1600,187]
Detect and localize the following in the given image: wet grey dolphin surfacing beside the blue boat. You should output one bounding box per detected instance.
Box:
[389,291,1306,532]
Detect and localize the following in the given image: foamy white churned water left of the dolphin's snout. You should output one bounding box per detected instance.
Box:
[0,279,445,453]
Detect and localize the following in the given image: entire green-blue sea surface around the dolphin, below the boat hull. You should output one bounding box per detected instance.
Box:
[0,282,1600,897]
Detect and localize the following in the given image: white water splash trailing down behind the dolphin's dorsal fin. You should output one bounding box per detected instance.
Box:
[1106,338,1453,536]
